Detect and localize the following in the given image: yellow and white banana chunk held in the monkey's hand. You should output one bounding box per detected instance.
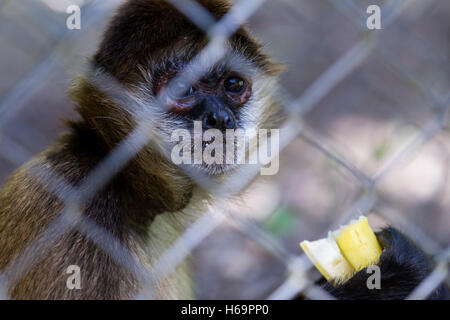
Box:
[300,216,382,283]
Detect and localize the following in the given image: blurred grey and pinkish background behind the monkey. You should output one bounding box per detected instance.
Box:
[0,0,450,299]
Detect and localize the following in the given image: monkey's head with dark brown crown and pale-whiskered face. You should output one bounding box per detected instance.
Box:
[76,0,281,175]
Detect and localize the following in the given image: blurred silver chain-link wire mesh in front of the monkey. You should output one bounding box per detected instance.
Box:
[0,0,450,299]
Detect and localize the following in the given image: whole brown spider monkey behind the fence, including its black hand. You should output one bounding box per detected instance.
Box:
[0,0,444,299]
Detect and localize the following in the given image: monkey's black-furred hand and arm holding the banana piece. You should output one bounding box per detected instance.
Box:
[323,227,450,300]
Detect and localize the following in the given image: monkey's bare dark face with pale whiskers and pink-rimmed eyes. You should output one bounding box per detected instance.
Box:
[142,51,279,175]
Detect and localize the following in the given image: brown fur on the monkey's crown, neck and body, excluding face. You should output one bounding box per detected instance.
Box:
[0,0,278,299]
